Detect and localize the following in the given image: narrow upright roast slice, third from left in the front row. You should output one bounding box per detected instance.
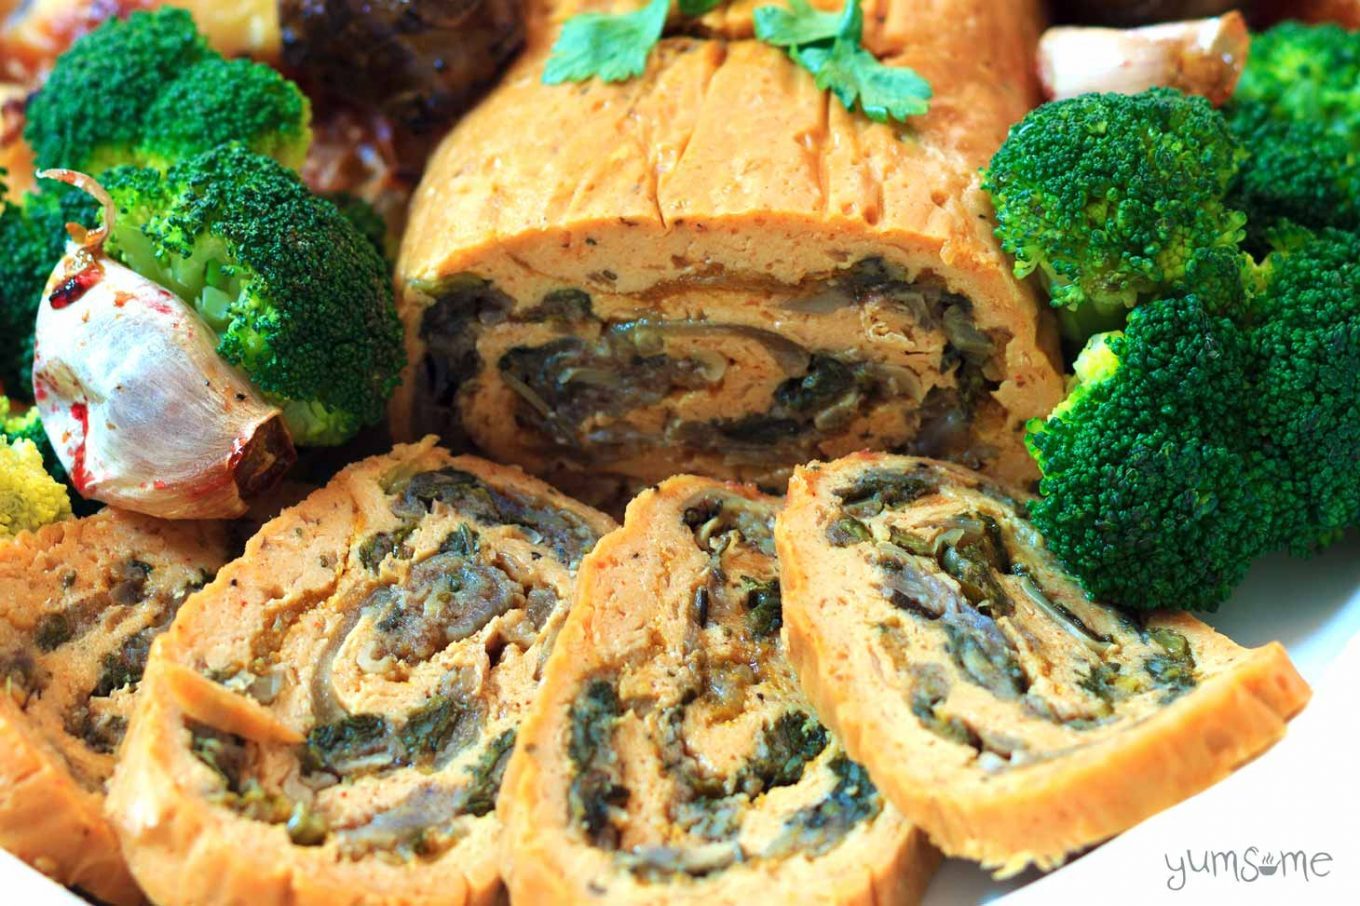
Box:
[499,476,938,906]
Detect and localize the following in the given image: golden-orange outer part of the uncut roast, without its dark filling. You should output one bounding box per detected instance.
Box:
[392,0,1062,495]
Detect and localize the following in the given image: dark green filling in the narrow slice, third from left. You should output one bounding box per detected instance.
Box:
[567,492,881,882]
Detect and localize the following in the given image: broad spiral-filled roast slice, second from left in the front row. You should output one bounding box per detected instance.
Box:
[109,438,613,906]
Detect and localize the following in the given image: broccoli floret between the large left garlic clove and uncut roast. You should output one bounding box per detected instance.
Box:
[105,144,405,445]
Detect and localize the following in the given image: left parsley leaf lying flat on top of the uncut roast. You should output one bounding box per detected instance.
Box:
[543,0,670,84]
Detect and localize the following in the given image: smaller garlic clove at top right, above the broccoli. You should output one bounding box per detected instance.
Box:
[1039,12,1251,106]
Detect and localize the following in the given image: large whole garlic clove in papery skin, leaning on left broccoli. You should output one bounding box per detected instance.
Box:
[33,243,295,518]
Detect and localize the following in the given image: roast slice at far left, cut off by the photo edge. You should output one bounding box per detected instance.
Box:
[0,509,228,906]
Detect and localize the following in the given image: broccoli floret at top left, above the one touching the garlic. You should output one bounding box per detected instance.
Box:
[24,8,311,175]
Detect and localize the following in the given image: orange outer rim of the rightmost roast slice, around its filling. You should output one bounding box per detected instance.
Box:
[777,454,1310,875]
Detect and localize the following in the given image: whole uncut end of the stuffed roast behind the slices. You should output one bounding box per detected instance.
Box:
[392,0,1062,503]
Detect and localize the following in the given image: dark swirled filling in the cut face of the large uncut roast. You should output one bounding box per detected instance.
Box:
[415,251,1008,465]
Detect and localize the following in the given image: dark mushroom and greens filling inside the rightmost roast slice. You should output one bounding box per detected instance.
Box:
[826,464,1198,770]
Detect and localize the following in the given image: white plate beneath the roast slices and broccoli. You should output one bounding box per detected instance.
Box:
[0,533,1360,906]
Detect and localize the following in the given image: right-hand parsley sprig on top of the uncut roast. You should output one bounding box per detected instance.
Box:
[755,0,930,122]
